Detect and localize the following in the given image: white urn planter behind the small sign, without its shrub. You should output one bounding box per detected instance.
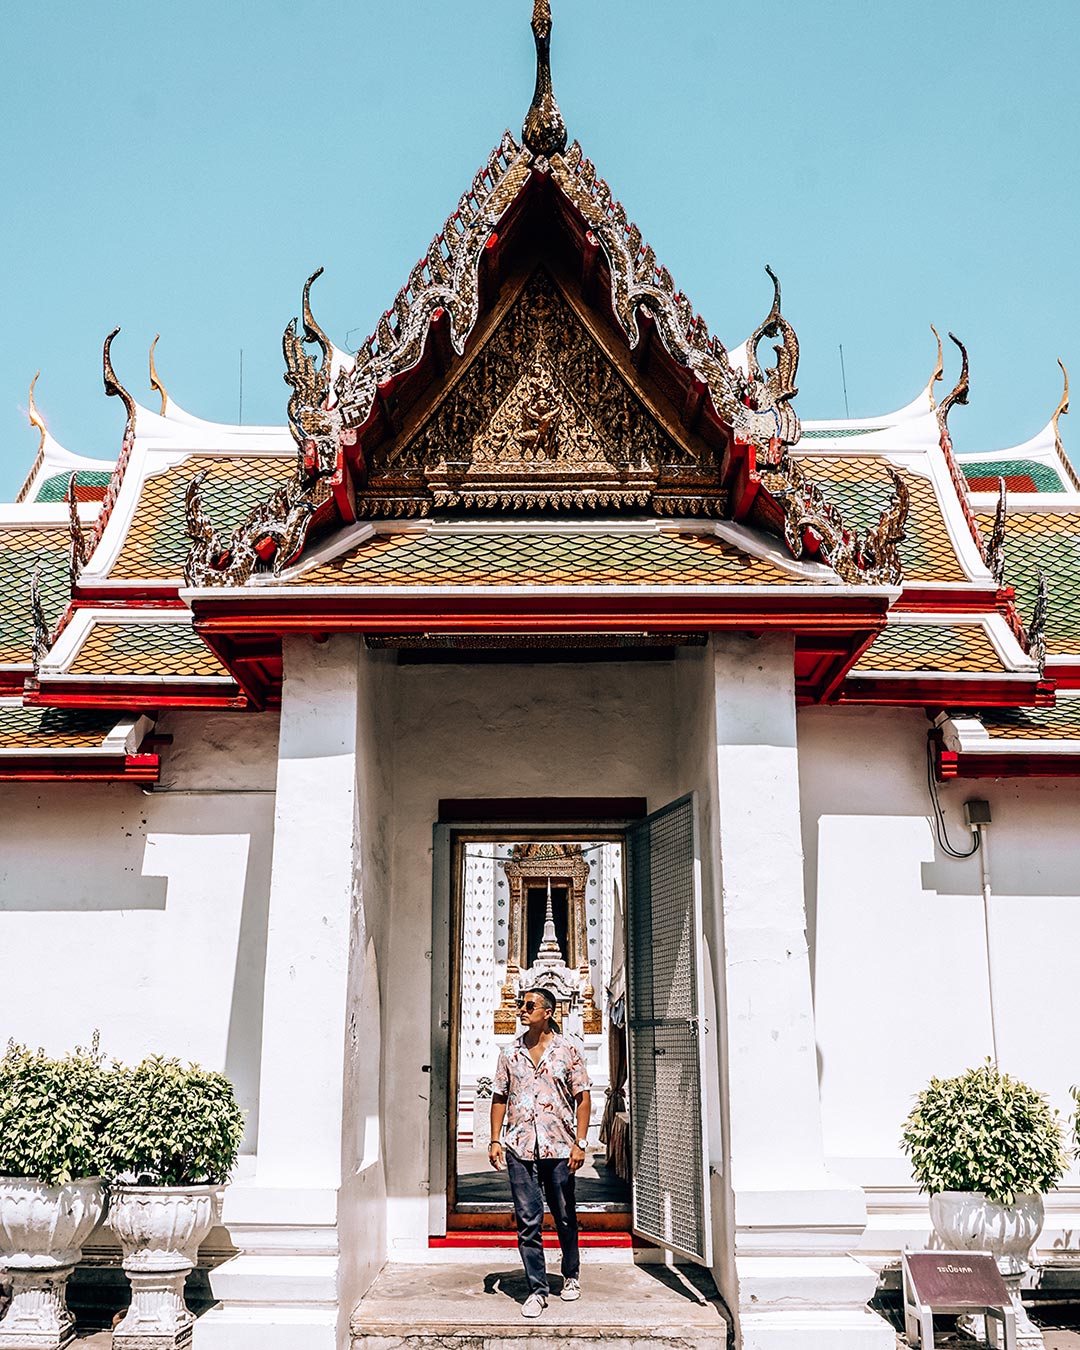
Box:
[930,1191,1044,1350]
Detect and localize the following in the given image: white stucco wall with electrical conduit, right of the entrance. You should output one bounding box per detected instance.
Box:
[799,709,1080,1188]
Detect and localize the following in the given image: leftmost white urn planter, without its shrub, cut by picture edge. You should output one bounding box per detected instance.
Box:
[0,1177,105,1350]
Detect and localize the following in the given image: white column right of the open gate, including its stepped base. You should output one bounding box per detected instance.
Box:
[711,635,894,1350]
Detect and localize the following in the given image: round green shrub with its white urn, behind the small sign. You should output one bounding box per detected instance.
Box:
[900,1062,1068,1339]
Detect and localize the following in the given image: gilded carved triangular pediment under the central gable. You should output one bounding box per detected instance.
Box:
[356,270,725,517]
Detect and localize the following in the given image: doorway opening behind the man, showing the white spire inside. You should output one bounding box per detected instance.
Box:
[447,832,630,1230]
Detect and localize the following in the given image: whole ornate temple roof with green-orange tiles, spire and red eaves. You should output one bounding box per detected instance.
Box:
[0,0,1080,772]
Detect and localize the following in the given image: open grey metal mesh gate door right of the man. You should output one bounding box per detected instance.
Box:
[626,797,711,1265]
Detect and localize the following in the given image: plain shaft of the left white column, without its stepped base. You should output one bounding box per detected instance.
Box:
[258,637,359,1187]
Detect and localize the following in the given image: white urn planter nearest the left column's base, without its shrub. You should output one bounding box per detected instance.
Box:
[108,1185,223,1350]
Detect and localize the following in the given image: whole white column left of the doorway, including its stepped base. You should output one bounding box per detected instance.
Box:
[194,636,363,1350]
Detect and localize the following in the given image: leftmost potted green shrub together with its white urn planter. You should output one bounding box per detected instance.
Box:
[0,1037,112,1350]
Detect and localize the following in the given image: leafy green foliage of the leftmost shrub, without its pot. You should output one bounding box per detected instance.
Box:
[0,1035,115,1185]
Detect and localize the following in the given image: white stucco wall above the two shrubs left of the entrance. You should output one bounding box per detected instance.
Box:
[0,713,277,1149]
